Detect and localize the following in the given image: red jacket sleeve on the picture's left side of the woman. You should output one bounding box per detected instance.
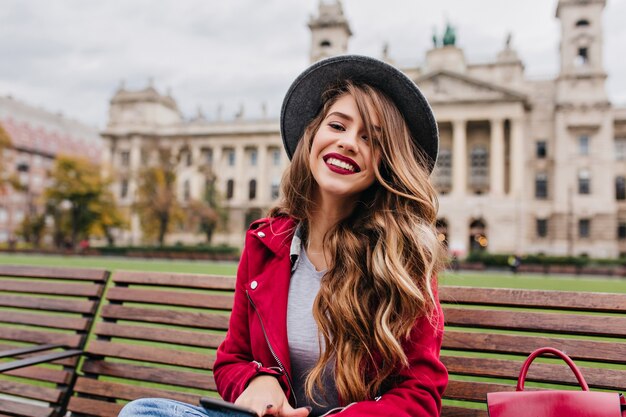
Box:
[213,242,279,402]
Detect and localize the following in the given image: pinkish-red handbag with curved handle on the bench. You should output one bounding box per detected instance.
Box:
[487,347,626,417]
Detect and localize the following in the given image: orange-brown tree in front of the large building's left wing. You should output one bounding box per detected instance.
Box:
[133,149,183,246]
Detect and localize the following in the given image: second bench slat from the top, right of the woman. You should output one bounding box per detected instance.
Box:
[444,307,626,337]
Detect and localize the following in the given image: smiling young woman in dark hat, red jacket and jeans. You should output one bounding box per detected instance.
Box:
[120,55,447,417]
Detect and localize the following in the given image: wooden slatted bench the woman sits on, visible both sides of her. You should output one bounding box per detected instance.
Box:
[57,272,626,417]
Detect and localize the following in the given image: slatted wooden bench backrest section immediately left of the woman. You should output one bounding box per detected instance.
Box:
[69,271,235,417]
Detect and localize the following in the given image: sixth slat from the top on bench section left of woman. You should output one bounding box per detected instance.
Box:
[82,361,217,391]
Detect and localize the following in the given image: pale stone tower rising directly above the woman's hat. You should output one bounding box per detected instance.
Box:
[309,0,352,63]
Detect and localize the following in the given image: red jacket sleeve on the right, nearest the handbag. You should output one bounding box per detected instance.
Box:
[337,296,448,417]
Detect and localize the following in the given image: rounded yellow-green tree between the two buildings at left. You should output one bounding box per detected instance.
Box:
[45,155,107,248]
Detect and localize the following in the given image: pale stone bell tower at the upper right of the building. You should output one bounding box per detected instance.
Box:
[556,0,608,104]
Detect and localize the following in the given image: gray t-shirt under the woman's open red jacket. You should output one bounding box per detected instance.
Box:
[287,236,339,417]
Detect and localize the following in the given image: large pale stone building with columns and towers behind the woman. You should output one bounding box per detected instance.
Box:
[102,0,626,257]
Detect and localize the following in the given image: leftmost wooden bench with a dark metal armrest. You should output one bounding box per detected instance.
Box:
[0,265,109,417]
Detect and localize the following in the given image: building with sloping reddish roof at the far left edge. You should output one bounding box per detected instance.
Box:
[0,97,102,244]
